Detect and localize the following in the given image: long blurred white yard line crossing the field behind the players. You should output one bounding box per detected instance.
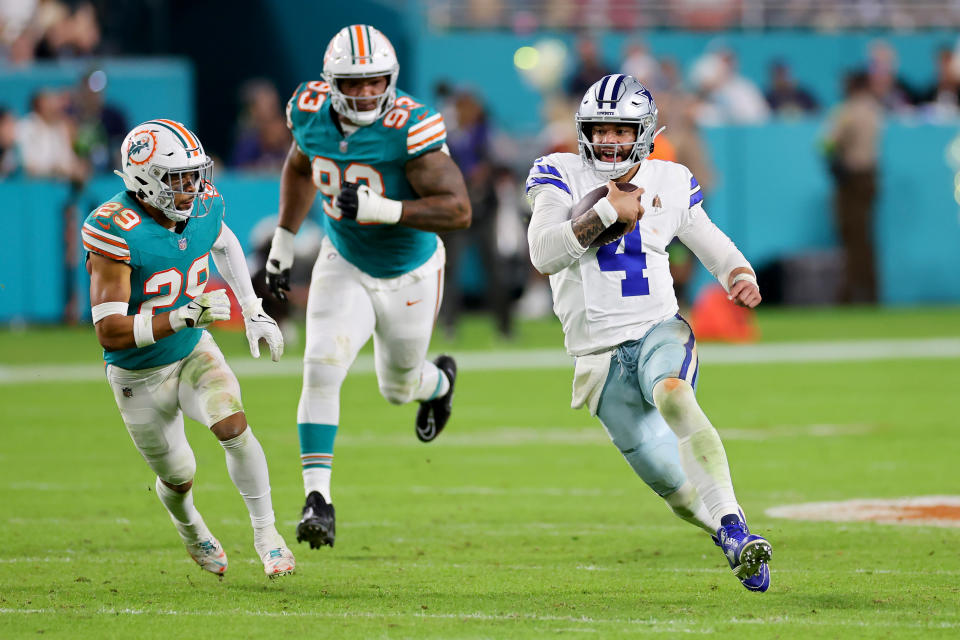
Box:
[0,338,960,385]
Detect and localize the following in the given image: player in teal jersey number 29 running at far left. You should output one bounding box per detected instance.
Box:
[81,119,294,578]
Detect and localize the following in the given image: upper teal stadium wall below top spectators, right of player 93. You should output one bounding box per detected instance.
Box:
[400,31,957,135]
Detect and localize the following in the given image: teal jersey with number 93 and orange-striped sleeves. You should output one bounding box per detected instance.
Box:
[287,81,447,278]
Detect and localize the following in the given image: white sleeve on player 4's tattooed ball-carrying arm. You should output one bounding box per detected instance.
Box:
[527,188,587,275]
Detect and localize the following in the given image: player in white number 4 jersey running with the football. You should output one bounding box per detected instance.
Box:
[526,74,771,591]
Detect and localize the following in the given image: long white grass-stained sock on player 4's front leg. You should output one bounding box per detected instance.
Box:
[653,378,739,521]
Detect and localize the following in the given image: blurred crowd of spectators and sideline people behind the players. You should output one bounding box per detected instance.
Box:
[0,0,960,328]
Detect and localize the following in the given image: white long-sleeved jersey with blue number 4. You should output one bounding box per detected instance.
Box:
[526,153,749,356]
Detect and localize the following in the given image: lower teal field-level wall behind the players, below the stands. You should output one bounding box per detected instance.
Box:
[0,122,960,322]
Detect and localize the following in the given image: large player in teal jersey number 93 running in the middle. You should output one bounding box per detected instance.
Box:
[267,24,470,548]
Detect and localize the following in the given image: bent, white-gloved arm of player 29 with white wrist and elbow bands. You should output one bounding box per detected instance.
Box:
[87,251,230,351]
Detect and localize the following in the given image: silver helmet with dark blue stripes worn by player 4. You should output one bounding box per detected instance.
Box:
[575,73,663,180]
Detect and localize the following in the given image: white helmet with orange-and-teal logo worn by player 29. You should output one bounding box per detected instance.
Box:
[114,119,214,222]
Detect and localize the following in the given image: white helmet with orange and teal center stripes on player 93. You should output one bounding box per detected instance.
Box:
[323,24,400,127]
